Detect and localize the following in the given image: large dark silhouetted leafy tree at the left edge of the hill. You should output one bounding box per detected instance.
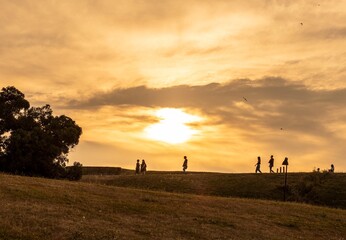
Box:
[0,87,82,178]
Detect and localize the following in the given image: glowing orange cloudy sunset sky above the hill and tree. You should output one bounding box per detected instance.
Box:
[0,0,346,173]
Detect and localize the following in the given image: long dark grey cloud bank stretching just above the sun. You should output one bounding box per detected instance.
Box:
[69,77,346,139]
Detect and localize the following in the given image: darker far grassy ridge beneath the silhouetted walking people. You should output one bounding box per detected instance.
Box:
[82,170,346,209]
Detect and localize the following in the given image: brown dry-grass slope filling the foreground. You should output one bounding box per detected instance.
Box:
[0,174,346,240]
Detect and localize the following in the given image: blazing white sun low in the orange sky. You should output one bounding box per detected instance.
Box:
[144,108,200,144]
